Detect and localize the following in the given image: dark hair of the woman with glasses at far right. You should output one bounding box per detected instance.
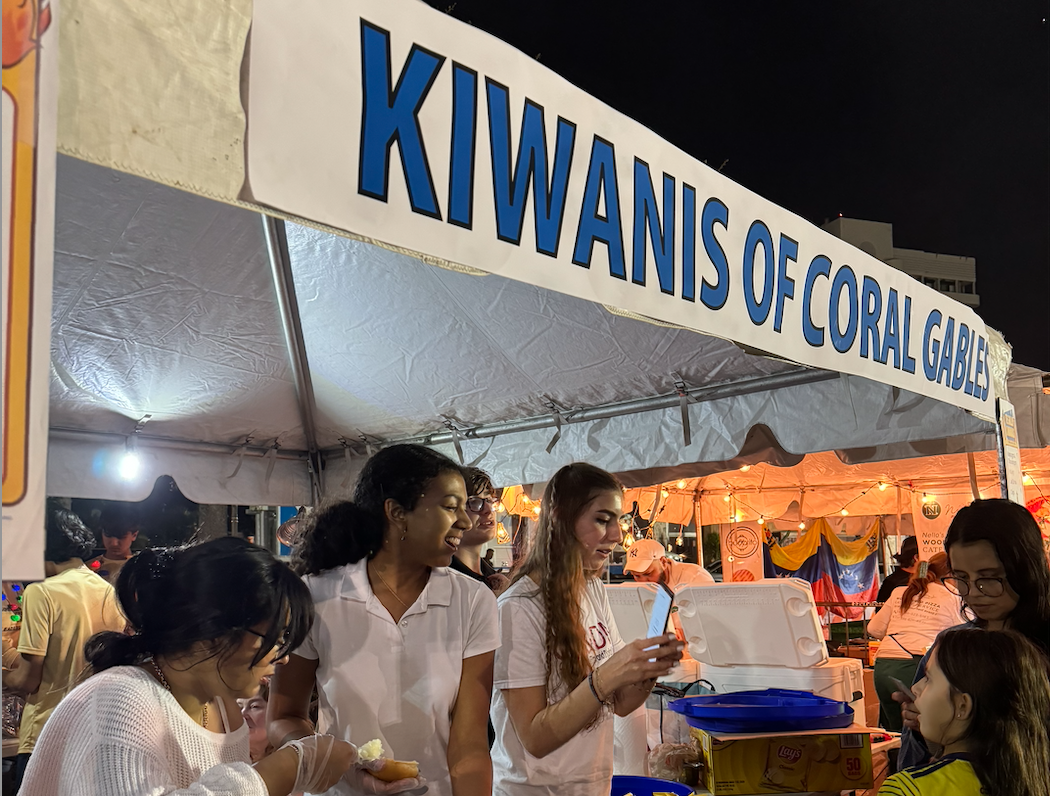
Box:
[944,498,1050,654]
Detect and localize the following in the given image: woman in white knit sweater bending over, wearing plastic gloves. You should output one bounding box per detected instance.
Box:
[16,538,369,796]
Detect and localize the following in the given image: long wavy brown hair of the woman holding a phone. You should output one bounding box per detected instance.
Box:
[512,462,624,724]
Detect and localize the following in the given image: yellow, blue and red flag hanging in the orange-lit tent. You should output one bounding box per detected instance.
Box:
[764,519,879,620]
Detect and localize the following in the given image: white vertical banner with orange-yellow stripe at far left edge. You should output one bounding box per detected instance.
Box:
[2,0,59,580]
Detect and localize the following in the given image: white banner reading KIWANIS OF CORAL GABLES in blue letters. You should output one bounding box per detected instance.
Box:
[242,0,1005,419]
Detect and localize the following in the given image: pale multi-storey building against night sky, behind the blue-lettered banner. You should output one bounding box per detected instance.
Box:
[821,216,981,307]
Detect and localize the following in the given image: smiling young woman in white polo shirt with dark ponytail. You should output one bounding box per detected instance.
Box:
[269,445,500,796]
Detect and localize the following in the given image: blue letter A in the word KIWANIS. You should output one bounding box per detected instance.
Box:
[572,135,627,280]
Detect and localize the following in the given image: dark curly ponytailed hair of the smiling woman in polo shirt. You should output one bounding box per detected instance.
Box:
[292,445,466,574]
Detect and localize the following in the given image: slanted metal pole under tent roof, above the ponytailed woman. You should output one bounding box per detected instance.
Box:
[260,214,324,504]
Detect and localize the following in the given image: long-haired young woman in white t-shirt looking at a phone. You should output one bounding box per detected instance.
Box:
[492,463,683,796]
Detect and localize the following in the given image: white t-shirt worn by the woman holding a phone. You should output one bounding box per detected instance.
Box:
[491,578,624,796]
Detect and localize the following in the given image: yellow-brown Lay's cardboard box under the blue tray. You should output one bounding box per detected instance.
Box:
[690,725,874,796]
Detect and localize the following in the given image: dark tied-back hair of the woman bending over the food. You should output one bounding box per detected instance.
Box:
[84,537,314,672]
